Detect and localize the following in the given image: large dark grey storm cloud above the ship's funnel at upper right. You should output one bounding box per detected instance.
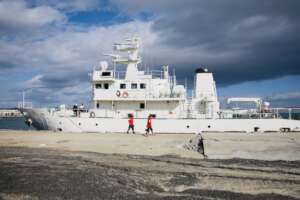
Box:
[112,0,300,85]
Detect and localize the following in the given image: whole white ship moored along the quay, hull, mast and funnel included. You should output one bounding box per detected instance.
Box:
[20,37,300,133]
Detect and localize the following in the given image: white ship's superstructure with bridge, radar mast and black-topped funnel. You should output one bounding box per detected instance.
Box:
[92,38,219,118]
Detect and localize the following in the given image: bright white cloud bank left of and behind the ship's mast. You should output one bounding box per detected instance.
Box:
[0,21,156,104]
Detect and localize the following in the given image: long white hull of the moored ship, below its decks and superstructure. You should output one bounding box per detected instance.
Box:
[21,109,300,133]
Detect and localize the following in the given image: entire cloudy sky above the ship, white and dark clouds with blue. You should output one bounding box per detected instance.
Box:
[0,0,300,107]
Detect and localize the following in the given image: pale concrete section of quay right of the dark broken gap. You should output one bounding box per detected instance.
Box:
[203,132,300,161]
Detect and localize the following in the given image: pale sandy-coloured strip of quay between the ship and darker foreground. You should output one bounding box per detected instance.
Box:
[0,130,300,161]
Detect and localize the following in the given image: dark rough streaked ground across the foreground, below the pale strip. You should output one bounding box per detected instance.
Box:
[0,147,300,200]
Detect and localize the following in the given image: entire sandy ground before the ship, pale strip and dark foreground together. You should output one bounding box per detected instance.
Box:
[0,131,300,200]
